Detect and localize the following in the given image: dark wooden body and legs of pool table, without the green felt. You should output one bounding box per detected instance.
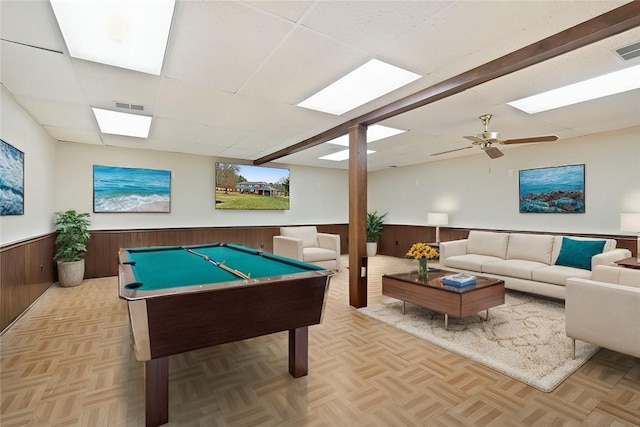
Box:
[118,249,333,426]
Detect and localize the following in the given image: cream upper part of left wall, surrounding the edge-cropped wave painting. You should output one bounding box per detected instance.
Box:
[0,86,57,245]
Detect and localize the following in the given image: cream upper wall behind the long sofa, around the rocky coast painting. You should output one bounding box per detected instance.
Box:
[368,127,640,234]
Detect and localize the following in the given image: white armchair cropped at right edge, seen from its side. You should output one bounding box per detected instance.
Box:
[565,265,640,357]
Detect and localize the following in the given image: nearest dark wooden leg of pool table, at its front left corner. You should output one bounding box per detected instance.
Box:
[144,357,169,427]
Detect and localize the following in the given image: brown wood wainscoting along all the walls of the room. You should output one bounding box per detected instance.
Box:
[0,224,637,330]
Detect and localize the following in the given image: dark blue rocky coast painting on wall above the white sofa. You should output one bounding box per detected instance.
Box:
[519,164,585,213]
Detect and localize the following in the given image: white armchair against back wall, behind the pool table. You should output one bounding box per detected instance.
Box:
[273,226,340,270]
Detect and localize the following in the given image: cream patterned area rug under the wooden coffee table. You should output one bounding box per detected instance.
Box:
[358,291,599,392]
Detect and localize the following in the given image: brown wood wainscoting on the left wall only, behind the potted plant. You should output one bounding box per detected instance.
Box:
[0,233,57,331]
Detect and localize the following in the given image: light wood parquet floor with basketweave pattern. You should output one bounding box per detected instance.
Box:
[0,256,640,427]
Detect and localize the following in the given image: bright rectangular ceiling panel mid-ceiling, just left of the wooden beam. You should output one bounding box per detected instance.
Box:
[298,59,421,115]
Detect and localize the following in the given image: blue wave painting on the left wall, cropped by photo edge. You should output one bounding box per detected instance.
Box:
[0,139,24,215]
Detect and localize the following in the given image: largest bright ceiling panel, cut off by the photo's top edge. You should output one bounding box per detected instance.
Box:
[50,0,175,75]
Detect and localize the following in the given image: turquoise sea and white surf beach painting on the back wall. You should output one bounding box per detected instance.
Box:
[93,165,171,213]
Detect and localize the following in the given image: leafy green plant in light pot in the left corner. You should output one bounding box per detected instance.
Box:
[54,210,91,286]
